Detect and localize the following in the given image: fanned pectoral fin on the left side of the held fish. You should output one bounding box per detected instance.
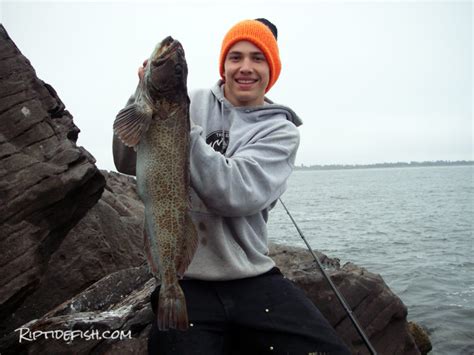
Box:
[114,103,153,147]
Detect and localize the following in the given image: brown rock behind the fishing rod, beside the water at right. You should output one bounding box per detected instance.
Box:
[271,245,420,354]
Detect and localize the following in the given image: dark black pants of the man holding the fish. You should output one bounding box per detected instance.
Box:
[148,268,350,355]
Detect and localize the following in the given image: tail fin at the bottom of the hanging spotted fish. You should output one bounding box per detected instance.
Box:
[158,283,189,330]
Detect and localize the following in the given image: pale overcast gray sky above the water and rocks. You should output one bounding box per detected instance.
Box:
[0,0,473,170]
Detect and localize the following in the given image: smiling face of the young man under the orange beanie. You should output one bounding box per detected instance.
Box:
[224,41,270,106]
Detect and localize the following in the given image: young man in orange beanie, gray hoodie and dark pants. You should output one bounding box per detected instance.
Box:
[114,19,349,355]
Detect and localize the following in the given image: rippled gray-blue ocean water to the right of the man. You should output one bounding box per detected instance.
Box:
[269,166,474,355]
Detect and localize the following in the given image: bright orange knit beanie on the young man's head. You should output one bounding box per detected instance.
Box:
[219,20,281,92]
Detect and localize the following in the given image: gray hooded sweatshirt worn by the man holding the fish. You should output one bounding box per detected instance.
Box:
[114,81,301,280]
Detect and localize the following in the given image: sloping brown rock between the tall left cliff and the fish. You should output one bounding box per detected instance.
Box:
[3,171,145,340]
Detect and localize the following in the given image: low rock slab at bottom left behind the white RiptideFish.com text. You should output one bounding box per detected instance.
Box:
[0,266,155,354]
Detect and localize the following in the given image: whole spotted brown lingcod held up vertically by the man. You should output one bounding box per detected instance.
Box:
[114,37,197,330]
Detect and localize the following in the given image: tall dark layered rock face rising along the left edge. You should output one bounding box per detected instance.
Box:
[0,25,105,335]
